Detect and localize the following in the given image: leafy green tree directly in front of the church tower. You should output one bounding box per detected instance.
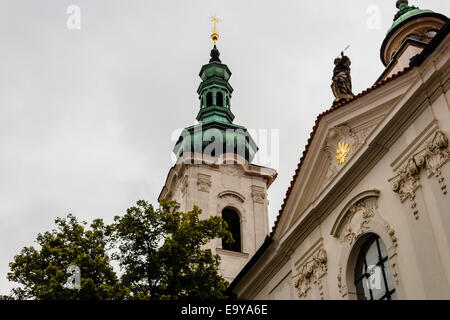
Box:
[113,201,232,299]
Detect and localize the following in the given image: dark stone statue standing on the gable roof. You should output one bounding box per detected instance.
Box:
[331,52,354,103]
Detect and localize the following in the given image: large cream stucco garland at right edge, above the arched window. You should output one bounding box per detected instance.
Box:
[389,130,450,219]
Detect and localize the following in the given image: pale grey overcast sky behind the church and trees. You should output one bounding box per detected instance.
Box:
[0,0,450,294]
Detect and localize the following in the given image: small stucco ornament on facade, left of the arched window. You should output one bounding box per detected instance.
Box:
[294,248,328,299]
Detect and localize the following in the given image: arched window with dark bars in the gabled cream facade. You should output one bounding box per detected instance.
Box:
[355,234,396,300]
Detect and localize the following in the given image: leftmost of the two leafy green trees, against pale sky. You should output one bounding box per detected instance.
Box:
[7,214,126,300]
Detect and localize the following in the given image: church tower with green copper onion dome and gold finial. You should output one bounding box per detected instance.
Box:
[159,17,277,282]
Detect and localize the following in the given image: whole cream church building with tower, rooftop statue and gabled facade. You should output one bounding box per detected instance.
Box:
[159,0,450,300]
